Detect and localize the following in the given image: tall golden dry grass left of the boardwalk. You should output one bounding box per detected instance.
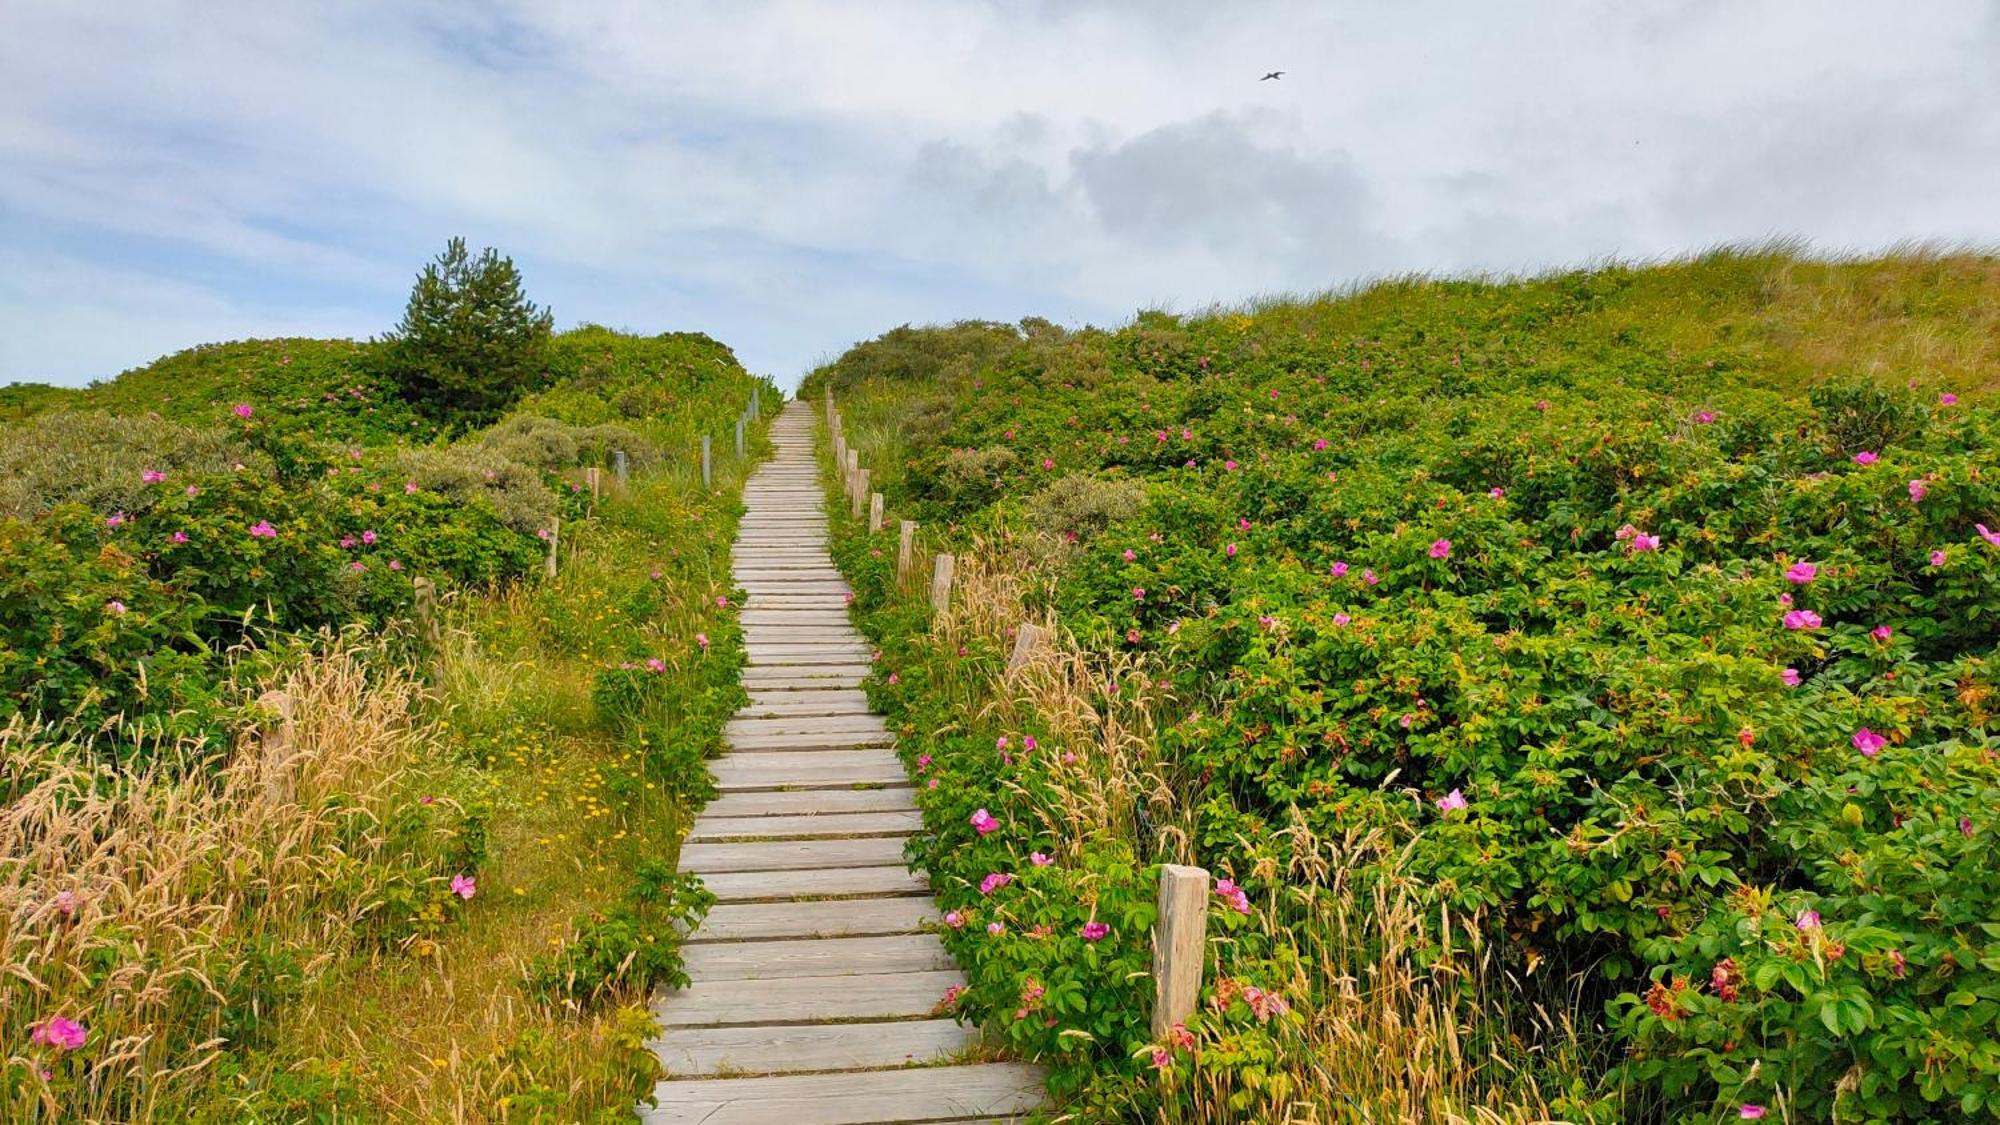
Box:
[0,637,458,1121]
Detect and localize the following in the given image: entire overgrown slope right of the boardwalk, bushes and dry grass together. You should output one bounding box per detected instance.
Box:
[802,246,2000,1121]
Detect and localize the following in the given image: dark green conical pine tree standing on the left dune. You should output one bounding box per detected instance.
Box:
[382,238,554,424]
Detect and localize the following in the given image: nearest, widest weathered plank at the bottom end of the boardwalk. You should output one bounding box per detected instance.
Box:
[640,1063,1044,1125]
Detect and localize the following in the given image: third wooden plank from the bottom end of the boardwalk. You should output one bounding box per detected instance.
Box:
[652,969,966,1027]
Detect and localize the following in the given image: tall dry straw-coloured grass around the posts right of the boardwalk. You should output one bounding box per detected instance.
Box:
[932,538,1590,1125]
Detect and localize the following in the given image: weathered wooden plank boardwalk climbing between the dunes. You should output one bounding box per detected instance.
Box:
[642,402,1042,1125]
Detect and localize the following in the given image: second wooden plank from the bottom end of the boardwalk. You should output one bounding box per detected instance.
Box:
[652,1019,980,1077]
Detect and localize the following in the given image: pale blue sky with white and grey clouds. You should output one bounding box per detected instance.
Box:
[0,0,2000,386]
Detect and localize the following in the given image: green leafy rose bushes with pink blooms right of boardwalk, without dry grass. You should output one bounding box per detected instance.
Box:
[802,252,2000,1119]
